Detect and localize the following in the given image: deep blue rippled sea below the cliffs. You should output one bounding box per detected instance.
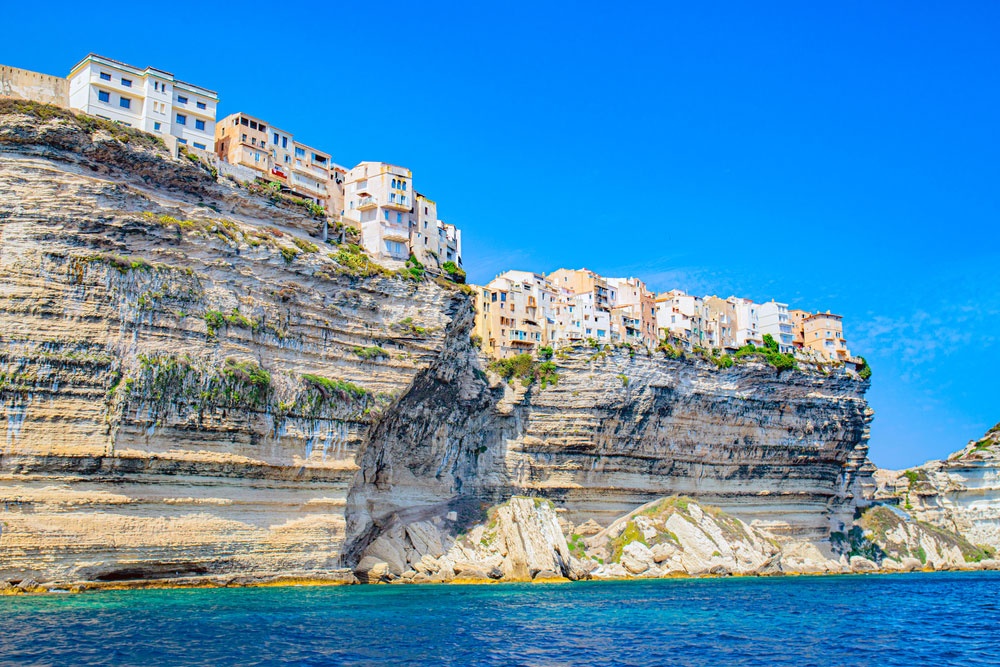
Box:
[0,572,1000,667]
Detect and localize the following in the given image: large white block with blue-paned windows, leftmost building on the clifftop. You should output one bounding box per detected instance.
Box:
[67,53,219,151]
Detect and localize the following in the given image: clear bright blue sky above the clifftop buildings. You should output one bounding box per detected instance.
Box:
[0,1,1000,467]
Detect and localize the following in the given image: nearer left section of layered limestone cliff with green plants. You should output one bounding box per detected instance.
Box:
[0,104,468,580]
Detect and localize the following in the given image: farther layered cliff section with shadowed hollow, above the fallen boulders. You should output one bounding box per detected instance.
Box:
[349,344,873,560]
